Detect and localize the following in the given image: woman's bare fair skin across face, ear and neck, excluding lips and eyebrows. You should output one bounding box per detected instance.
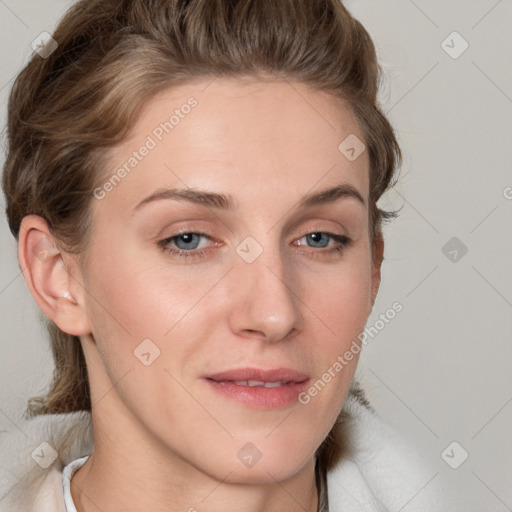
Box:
[19,78,383,512]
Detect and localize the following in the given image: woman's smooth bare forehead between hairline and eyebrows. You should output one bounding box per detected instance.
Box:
[97,79,369,212]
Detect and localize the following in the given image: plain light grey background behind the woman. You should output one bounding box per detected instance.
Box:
[0,0,512,512]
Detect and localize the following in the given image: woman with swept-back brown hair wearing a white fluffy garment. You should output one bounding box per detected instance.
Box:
[0,0,452,512]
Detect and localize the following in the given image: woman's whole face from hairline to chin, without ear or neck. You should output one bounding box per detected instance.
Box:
[73,79,378,482]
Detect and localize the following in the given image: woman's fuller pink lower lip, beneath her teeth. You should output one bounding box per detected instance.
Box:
[205,379,309,409]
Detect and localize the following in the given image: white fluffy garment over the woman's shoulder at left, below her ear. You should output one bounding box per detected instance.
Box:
[0,411,93,512]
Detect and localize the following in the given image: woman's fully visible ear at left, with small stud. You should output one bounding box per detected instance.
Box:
[18,215,91,336]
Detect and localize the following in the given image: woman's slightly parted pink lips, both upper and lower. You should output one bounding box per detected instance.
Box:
[203,368,310,409]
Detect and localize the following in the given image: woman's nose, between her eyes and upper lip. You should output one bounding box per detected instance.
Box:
[230,241,303,343]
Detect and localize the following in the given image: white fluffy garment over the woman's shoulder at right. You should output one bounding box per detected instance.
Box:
[327,383,455,512]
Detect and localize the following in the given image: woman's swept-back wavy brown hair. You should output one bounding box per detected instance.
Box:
[3,0,401,472]
